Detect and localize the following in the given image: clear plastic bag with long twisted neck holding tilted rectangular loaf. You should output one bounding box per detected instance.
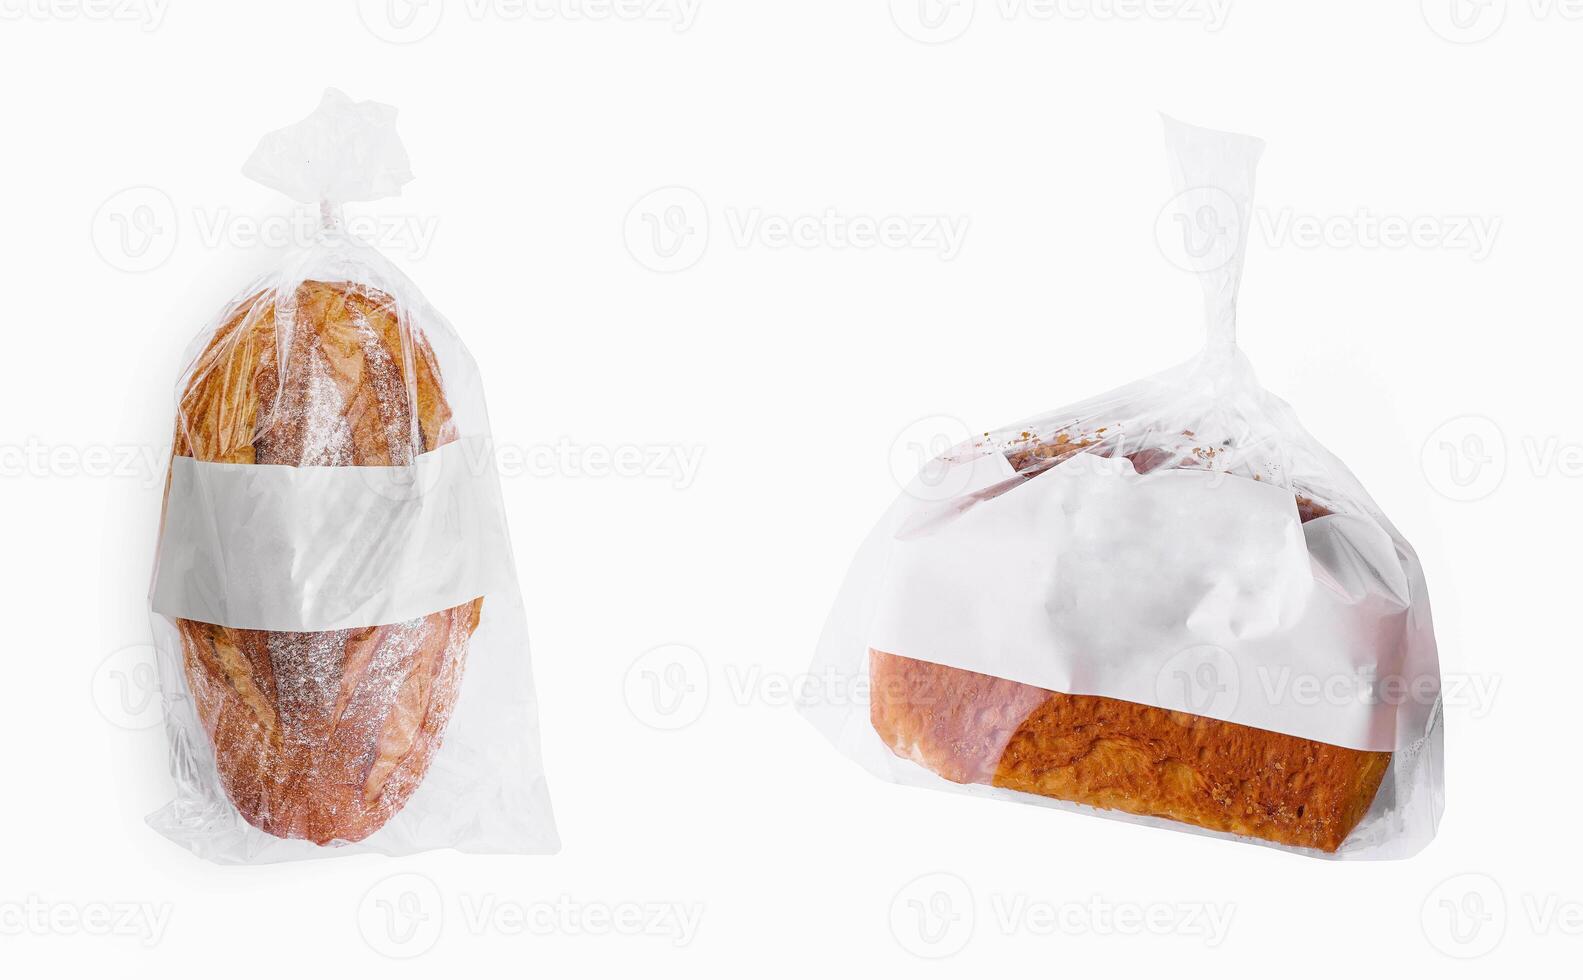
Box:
[804,120,1444,858]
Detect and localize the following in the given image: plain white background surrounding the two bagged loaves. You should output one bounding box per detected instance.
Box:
[0,0,1583,977]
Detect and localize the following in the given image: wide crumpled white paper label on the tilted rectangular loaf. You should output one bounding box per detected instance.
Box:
[867,454,1437,750]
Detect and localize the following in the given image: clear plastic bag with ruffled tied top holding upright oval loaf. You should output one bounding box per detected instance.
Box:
[149,90,559,863]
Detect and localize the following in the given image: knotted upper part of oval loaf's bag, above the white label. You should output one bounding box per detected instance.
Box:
[177,89,488,465]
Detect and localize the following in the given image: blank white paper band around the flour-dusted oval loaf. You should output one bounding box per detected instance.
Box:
[152,439,511,632]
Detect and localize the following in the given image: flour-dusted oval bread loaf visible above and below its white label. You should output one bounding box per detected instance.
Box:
[174,282,483,844]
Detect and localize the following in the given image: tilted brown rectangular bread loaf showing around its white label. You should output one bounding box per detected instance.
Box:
[869,429,1391,852]
